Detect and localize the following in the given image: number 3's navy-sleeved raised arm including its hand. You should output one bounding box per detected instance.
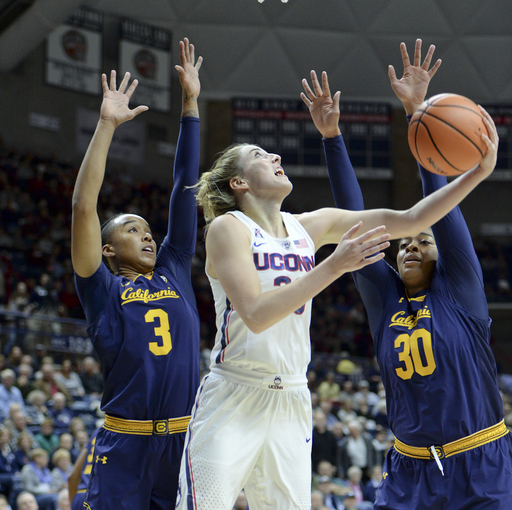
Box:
[168,38,203,254]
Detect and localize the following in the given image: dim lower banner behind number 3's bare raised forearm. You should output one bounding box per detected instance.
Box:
[76,108,145,165]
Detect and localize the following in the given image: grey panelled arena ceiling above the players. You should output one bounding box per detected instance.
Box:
[0,0,512,103]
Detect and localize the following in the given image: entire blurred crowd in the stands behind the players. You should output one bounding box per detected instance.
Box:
[0,146,512,510]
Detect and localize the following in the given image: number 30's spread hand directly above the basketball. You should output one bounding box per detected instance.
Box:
[388,39,441,115]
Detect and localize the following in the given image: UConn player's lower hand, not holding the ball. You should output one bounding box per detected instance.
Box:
[331,221,390,273]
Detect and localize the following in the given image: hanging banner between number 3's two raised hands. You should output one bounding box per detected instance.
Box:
[119,19,171,112]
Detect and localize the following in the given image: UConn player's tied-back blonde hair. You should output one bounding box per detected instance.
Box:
[194,143,249,228]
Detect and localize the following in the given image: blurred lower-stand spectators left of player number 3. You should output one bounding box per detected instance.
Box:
[0,345,103,510]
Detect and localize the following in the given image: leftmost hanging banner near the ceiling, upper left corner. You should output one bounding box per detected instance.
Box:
[45,7,103,94]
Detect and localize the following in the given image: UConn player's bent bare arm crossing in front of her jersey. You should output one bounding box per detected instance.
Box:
[206,214,389,333]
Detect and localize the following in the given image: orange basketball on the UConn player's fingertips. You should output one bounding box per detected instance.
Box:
[408,94,488,175]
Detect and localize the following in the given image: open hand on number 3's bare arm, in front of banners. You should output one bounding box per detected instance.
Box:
[100,71,148,127]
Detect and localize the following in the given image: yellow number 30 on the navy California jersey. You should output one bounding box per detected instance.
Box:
[395,328,436,380]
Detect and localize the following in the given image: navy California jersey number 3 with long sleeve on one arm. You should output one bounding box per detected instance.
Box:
[75,117,199,420]
